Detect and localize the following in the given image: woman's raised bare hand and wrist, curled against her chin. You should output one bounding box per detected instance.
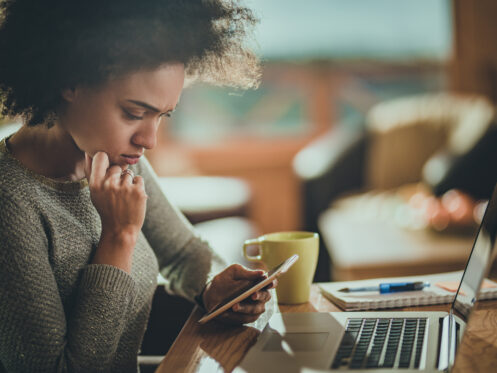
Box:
[85,152,147,272]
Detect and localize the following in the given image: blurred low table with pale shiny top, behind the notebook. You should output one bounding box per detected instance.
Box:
[319,201,474,281]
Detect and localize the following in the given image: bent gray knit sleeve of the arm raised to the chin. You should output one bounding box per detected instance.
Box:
[0,193,136,372]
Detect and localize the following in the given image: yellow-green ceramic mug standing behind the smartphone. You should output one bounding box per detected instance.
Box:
[243,231,319,304]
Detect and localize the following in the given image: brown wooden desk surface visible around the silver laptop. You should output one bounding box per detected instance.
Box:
[156,285,497,373]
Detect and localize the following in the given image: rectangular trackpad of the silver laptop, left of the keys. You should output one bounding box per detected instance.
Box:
[262,332,328,351]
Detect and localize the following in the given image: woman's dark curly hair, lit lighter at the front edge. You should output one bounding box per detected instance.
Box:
[0,0,260,126]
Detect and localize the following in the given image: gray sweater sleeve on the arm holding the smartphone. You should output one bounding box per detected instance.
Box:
[137,159,226,301]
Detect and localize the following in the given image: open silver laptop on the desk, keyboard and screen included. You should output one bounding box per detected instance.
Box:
[235,187,497,373]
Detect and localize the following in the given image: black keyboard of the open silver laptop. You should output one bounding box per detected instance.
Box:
[331,318,427,369]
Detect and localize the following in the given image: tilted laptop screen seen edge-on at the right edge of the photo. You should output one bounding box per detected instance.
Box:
[452,183,497,322]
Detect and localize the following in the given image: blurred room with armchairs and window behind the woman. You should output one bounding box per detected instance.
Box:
[3,0,497,280]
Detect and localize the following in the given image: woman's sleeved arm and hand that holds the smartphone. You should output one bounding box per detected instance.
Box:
[137,160,271,324]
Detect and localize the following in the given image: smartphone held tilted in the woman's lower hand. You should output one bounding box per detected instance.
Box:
[198,254,299,324]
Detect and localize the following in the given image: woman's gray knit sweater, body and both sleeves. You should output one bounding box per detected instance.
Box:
[0,140,223,372]
